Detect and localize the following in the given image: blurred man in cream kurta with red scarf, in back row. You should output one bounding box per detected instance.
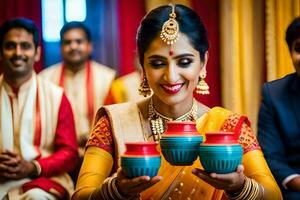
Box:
[40,22,115,155]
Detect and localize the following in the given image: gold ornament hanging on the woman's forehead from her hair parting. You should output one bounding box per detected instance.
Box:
[160,4,179,45]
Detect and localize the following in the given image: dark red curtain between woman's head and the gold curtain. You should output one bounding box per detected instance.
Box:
[193,0,221,107]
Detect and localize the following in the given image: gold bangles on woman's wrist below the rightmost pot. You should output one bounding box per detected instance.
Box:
[226,177,263,200]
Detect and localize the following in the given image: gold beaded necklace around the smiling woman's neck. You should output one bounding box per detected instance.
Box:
[148,98,198,141]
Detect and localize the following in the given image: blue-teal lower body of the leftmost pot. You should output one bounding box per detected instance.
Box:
[121,156,161,178]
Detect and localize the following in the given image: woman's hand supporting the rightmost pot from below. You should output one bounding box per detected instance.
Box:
[192,165,245,192]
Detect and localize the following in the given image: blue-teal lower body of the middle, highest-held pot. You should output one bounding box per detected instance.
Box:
[160,135,203,166]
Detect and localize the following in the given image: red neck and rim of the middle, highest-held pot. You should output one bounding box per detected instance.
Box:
[164,121,199,136]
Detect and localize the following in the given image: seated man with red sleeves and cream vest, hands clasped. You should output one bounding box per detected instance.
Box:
[0,18,78,200]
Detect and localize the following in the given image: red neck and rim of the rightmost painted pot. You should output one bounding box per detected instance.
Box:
[203,131,238,144]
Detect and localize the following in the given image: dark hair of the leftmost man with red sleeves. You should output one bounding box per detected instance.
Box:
[0,18,40,51]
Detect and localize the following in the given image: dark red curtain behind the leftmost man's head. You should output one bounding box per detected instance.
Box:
[0,0,42,71]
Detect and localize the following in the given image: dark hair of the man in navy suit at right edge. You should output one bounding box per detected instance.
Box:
[285,17,300,51]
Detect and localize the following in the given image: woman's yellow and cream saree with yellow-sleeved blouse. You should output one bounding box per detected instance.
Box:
[73,104,281,200]
